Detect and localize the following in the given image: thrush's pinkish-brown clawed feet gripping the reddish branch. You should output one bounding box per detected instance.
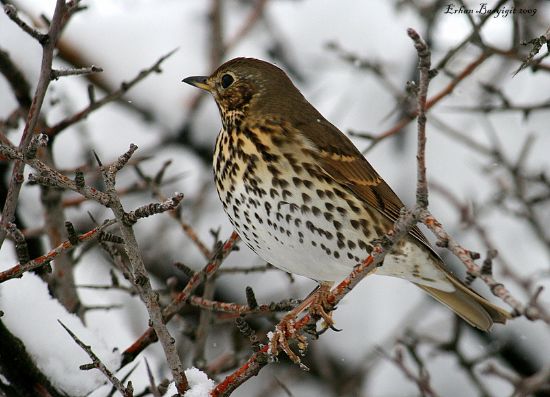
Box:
[269,282,334,369]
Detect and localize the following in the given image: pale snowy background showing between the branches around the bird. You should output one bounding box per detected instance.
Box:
[0,0,550,396]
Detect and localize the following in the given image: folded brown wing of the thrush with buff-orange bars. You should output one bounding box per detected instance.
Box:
[300,118,431,244]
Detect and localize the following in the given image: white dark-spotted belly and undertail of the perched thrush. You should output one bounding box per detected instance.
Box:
[225,178,454,291]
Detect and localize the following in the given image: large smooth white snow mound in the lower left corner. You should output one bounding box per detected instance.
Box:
[0,273,120,396]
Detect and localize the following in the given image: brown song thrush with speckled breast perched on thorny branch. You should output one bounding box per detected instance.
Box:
[183,58,509,331]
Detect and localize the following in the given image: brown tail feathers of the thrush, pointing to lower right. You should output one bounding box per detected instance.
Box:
[417,274,511,331]
